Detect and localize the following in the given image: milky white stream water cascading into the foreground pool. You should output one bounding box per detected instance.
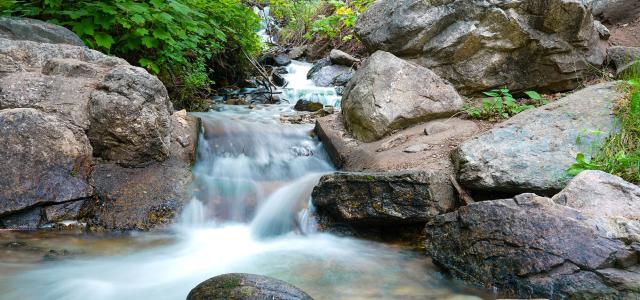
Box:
[0,62,484,300]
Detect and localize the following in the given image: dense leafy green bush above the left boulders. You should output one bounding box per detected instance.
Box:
[5,0,260,108]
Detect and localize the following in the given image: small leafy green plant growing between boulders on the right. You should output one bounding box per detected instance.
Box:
[464,88,547,120]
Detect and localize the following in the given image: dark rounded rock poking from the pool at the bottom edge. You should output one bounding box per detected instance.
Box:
[187,273,312,300]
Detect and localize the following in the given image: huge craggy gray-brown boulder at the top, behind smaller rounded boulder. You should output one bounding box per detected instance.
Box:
[356,0,604,94]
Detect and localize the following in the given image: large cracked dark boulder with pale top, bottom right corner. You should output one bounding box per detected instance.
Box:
[426,172,640,299]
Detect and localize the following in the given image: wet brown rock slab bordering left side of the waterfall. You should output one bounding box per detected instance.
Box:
[86,112,199,230]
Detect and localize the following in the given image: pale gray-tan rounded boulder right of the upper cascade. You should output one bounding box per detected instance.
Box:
[342,51,463,142]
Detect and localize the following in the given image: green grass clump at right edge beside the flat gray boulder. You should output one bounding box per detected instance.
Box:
[567,72,640,184]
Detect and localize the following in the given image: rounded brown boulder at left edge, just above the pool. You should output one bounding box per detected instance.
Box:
[0,108,94,216]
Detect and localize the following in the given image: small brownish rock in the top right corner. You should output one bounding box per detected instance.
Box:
[587,0,640,24]
